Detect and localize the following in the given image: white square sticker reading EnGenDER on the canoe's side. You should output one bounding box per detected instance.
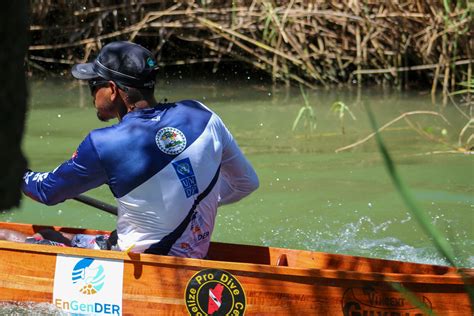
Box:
[53,255,123,315]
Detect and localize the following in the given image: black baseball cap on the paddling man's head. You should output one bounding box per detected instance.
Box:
[71,42,158,89]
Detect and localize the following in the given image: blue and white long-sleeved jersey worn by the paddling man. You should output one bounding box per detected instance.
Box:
[23,100,258,258]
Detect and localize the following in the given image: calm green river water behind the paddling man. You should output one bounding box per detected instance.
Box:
[0,80,474,267]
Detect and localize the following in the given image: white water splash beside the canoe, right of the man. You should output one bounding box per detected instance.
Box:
[260,215,474,267]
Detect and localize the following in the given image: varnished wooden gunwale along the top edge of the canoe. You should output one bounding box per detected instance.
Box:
[0,222,474,286]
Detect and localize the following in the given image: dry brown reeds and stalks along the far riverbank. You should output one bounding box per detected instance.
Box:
[27,0,473,99]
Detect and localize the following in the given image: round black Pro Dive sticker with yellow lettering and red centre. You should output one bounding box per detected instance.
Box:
[185,269,245,316]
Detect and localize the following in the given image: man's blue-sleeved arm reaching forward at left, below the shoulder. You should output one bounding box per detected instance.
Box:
[22,134,107,205]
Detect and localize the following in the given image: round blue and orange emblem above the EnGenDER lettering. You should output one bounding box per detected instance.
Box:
[72,258,105,295]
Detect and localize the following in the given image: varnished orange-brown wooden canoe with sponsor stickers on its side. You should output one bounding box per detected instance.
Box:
[0,222,474,316]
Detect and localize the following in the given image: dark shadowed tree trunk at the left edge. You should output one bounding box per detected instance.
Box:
[0,0,28,210]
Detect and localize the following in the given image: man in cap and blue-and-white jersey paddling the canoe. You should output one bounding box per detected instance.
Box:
[19,42,258,258]
